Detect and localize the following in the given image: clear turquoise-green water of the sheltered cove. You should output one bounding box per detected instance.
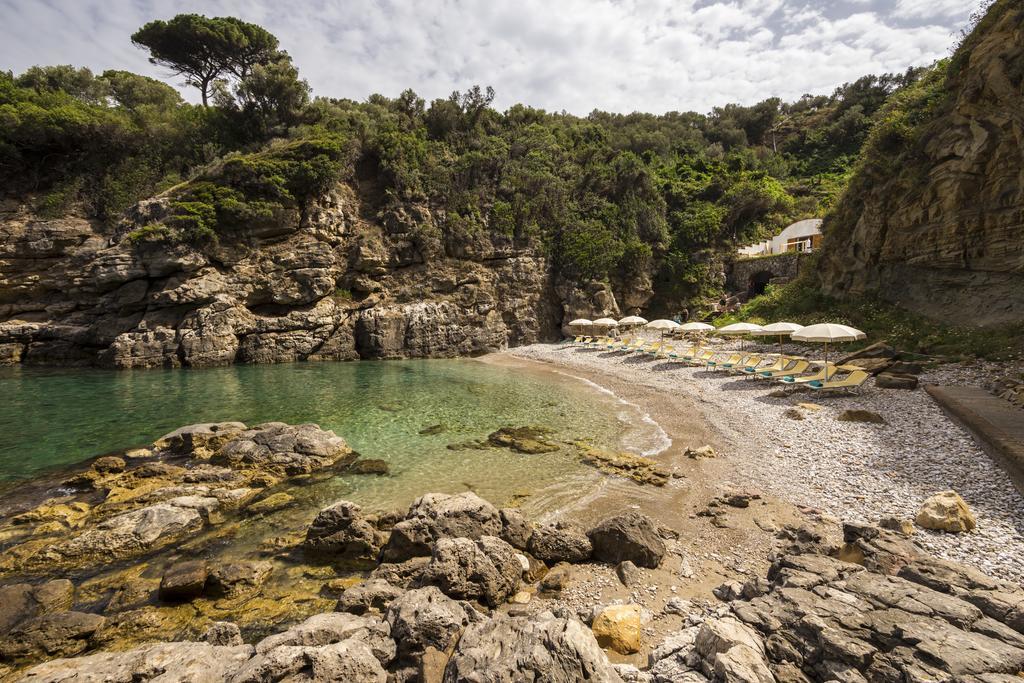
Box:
[0,359,662,510]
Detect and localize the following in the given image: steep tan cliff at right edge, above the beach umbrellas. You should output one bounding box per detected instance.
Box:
[820,2,1024,326]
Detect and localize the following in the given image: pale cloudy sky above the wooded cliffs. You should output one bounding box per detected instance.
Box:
[0,0,982,115]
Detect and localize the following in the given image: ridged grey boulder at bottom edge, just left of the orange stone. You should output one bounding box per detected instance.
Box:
[444,612,622,683]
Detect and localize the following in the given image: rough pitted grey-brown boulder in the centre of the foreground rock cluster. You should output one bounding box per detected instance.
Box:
[420,536,523,607]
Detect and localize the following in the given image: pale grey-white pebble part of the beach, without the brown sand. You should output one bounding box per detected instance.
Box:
[511,343,1024,583]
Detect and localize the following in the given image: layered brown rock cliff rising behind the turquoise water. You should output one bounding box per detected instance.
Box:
[0,179,649,368]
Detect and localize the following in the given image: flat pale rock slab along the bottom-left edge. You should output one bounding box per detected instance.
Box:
[22,642,253,683]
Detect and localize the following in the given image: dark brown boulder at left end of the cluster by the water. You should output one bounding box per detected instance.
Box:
[303,501,386,567]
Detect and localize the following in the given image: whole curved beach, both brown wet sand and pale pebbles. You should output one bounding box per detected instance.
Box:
[501,344,1024,583]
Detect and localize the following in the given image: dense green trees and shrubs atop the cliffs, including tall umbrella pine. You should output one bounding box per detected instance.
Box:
[0,15,921,298]
